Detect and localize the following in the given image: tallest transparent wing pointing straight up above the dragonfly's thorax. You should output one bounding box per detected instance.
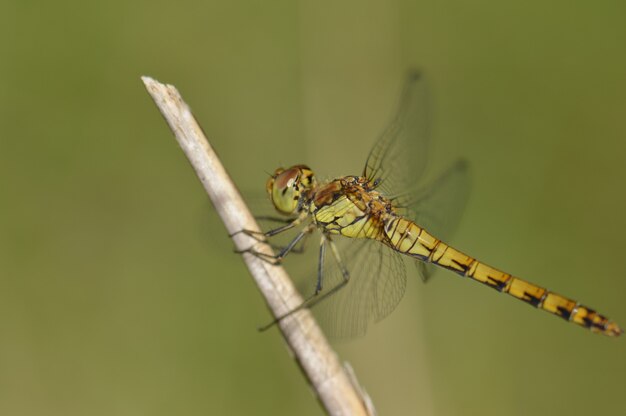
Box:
[363,71,430,197]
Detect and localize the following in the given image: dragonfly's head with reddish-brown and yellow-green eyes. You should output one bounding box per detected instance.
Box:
[265,165,315,215]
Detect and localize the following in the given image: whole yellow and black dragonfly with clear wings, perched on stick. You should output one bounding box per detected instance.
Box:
[242,71,622,337]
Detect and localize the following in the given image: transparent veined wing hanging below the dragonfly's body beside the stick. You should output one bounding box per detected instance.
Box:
[294,236,406,339]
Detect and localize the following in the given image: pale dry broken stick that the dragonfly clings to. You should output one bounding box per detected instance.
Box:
[142,77,375,415]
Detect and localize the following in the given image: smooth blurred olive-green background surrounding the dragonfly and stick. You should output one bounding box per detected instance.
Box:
[0,0,626,415]
